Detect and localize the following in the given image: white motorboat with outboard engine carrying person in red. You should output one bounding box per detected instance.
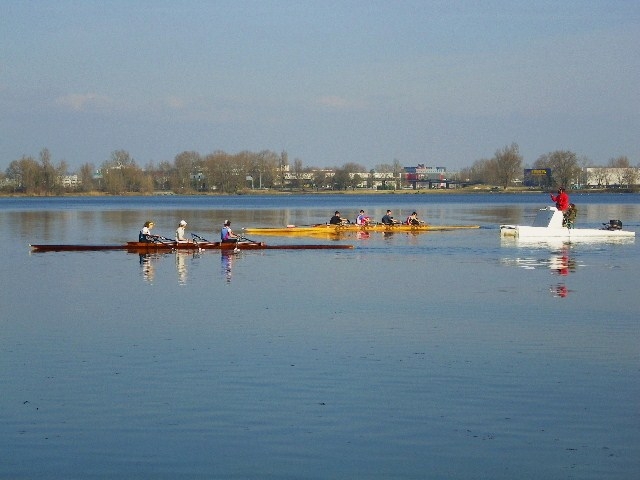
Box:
[500,207,636,241]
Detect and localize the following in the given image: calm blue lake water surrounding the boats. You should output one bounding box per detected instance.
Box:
[0,194,640,479]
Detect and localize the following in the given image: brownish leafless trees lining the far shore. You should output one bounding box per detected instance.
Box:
[0,143,635,195]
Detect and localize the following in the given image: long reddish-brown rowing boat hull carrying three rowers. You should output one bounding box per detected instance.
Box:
[30,242,353,253]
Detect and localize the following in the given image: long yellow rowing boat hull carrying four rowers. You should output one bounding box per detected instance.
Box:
[243,223,480,236]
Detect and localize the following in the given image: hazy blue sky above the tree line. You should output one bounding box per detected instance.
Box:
[0,0,640,171]
